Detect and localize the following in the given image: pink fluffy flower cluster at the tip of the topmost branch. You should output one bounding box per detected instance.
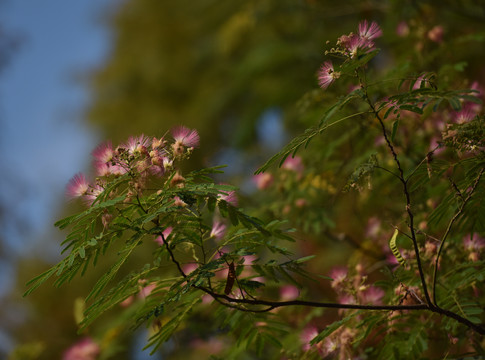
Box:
[318,20,382,89]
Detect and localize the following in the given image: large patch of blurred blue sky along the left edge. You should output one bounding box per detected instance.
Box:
[0,0,116,260]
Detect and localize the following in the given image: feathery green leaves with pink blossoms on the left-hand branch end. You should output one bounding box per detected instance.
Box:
[25,129,308,352]
